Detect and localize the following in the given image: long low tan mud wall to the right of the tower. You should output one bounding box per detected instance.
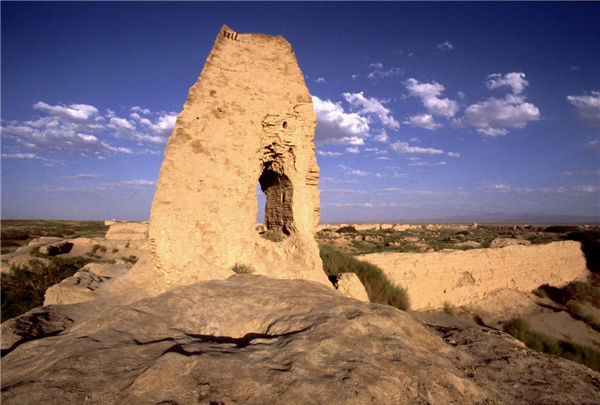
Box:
[357,241,589,310]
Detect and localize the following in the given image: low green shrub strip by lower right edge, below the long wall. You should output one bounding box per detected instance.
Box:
[503,318,600,371]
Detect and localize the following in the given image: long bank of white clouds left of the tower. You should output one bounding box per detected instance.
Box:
[2,101,177,158]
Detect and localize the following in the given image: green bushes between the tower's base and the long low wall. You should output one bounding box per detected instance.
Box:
[320,245,409,311]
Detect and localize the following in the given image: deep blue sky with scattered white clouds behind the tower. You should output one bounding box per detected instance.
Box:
[1,2,600,222]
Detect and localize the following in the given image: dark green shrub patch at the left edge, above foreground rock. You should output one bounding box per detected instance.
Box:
[1,257,91,321]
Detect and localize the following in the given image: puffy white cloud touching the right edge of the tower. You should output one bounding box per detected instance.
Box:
[312,96,369,145]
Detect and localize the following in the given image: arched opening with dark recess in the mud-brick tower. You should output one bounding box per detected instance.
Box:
[258,168,295,242]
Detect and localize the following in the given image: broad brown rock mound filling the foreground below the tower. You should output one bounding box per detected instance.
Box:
[2,275,600,404]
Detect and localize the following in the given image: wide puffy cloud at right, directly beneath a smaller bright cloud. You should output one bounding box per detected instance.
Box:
[465,94,540,136]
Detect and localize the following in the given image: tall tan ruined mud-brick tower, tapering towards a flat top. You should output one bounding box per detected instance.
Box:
[149,26,329,284]
